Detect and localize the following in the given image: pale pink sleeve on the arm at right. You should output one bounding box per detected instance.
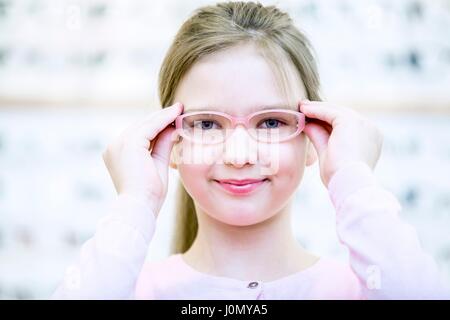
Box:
[328,162,450,299]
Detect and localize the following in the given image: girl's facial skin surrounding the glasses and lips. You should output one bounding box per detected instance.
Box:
[171,44,315,226]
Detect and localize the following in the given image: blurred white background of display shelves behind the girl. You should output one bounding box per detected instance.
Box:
[0,0,450,299]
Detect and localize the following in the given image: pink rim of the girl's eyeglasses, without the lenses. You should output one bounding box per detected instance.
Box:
[175,109,305,142]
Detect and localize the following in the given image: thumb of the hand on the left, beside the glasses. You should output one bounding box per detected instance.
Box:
[151,126,177,180]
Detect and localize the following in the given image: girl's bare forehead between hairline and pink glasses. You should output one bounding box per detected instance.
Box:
[175,45,304,116]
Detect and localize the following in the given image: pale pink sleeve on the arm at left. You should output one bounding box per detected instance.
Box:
[51,195,156,299]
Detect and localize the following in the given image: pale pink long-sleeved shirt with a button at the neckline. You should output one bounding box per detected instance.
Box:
[52,163,450,300]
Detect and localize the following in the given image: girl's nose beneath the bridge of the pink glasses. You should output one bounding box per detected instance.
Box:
[223,125,257,168]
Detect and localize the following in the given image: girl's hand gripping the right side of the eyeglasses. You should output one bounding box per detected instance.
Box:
[299,100,383,187]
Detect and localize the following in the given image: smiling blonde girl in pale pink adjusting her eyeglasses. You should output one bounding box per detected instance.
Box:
[53,2,449,299]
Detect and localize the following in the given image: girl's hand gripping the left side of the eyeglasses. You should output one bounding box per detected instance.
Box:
[103,103,183,216]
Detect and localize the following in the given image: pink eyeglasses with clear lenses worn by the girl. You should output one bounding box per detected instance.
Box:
[175,109,305,144]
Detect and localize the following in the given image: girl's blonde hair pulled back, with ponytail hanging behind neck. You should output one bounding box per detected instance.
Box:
[159,2,320,254]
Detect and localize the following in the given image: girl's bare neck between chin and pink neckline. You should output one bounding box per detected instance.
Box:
[183,201,317,281]
